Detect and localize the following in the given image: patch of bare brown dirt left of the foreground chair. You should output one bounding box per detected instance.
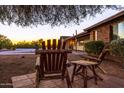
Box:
[0,55,35,83]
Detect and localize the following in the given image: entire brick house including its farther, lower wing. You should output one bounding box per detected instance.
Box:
[66,11,124,50]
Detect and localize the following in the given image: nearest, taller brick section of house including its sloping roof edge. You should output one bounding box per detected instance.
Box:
[84,11,124,42]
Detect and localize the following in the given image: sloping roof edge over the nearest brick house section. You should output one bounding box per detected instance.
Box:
[84,10,124,31]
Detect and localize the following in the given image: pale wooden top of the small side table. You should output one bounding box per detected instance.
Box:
[71,60,98,66]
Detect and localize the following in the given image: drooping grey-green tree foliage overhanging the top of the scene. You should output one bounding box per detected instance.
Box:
[0,5,120,26]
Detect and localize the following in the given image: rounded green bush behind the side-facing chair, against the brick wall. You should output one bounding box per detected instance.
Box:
[84,41,104,55]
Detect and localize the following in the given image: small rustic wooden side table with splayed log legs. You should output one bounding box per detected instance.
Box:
[71,60,99,88]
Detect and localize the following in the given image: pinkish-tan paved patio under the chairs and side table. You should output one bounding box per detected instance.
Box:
[12,70,124,88]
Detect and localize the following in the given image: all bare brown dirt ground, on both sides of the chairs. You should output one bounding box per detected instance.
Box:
[0,54,124,83]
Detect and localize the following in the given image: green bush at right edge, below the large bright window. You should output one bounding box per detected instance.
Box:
[110,39,124,57]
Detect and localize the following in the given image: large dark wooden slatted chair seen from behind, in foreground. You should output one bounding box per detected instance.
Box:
[36,39,72,87]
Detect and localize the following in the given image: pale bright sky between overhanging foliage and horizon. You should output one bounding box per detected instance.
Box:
[0,9,120,43]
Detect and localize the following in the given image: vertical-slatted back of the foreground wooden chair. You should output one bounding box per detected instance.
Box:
[40,39,67,74]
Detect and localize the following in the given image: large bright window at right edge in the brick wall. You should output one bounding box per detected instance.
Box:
[113,22,124,40]
